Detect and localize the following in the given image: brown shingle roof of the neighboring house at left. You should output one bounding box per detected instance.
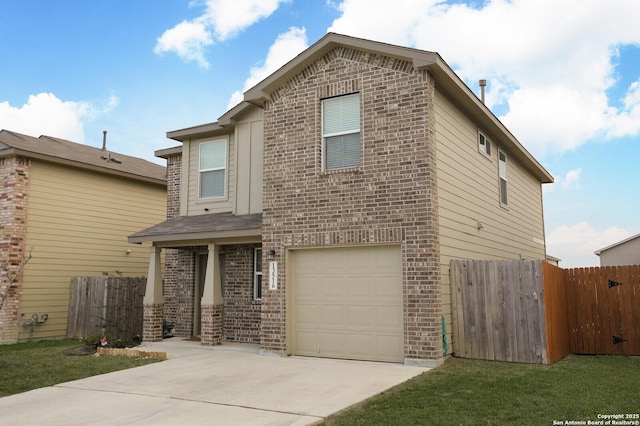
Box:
[0,130,167,185]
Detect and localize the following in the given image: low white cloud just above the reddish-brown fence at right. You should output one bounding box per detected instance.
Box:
[547,222,631,268]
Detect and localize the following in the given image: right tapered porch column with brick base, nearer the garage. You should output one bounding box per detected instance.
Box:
[200,244,223,346]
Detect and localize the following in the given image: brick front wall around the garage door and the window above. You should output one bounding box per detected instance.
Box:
[261,47,442,359]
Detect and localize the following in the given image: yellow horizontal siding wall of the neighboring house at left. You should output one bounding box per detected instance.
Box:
[19,160,166,340]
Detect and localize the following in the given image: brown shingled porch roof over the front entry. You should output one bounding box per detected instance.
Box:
[128,212,262,246]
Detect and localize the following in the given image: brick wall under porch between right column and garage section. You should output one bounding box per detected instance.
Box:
[222,244,261,344]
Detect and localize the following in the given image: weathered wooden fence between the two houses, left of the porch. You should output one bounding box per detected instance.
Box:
[67,276,147,339]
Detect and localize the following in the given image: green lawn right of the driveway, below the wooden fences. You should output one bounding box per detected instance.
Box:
[324,355,640,425]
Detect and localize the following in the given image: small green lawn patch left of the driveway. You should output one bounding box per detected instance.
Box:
[0,339,158,397]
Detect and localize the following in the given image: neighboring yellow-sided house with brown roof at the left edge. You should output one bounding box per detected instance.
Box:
[0,130,167,343]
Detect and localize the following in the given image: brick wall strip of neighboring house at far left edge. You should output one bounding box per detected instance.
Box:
[0,157,31,344]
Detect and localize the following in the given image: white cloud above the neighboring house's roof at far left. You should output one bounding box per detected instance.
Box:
[0,93,119,143]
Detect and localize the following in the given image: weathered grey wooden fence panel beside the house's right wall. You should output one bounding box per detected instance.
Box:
[451,260,549,364]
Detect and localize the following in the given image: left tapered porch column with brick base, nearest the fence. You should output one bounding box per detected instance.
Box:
[142,246,164,342]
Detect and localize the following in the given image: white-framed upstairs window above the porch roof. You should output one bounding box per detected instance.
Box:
[199,139,227,198]
